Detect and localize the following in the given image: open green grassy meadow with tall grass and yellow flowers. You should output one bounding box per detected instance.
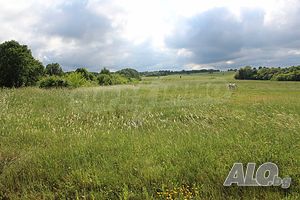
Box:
[0,73,300,199]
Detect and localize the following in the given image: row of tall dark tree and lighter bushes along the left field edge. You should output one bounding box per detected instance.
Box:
[0,40,141,88]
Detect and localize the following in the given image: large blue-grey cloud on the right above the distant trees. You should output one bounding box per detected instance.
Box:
[166,0,300,68]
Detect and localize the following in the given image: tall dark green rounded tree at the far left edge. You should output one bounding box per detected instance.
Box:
[0,40,44,87]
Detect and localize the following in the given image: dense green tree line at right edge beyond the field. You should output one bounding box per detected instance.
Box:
[234,66,300,81]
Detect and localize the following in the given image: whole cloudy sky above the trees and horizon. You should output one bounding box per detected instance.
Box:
[0,0,300,72]
